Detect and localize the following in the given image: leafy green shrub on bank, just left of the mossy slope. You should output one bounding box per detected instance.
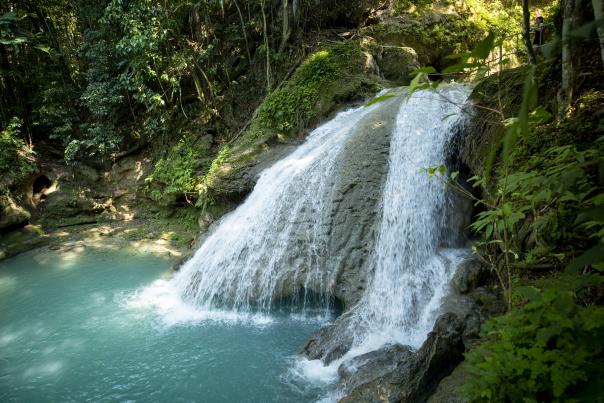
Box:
[145,140,208,201]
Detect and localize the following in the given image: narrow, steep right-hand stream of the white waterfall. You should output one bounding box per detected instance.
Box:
[351,86,469,347]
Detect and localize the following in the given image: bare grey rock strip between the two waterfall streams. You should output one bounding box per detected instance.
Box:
[329,97,401,308]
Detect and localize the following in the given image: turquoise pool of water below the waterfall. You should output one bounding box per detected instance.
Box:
[0,248,330,402]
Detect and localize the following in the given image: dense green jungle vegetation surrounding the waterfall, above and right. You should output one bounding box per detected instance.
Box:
[0,0,604,402]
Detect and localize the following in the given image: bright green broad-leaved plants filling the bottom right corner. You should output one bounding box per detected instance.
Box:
[466,278,604,402]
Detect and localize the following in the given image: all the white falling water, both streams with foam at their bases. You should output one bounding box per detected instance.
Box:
[133,86,469,381]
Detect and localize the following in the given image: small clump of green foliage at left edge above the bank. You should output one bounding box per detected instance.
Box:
[0,117,36,183]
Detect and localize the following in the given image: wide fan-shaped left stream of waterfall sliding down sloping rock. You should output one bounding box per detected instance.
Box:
[174,96,386,312]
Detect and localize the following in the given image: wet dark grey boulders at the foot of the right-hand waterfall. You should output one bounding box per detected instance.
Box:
[303,258,503,403]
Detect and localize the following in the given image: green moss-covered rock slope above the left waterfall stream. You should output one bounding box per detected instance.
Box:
[199,40,381,202]
